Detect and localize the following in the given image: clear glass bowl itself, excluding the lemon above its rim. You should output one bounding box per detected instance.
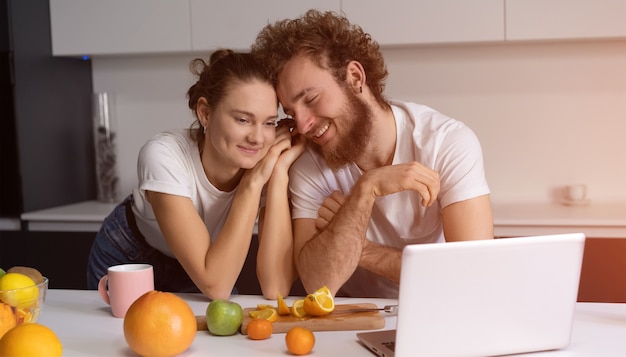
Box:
[0,277,48,326]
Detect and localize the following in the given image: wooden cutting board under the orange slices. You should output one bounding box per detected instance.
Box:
[196,303,385,335]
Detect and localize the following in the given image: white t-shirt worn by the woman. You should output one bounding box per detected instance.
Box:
[133,129,237,257]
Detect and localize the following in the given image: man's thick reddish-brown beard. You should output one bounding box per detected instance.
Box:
[320,88,372,170]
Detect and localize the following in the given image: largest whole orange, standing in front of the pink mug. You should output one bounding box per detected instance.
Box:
[124,290,197,357]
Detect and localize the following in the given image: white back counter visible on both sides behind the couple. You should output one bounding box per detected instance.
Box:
[21,201,626,238]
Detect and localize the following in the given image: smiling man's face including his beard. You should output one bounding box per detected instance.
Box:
[277,56,372,169]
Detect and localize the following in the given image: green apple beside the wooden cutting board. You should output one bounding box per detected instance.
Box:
[206,299,243,336]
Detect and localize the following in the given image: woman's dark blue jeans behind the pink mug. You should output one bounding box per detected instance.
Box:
[87,195,201,293]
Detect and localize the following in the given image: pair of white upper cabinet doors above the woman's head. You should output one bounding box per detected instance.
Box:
[50,0,340,56]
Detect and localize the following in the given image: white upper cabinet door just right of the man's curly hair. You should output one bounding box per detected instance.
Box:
[342,0,504,46]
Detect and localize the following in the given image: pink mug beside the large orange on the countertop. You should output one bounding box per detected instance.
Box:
[98,264,154,318]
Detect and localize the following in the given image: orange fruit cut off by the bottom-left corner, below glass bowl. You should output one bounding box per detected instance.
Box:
[0,323,63,357]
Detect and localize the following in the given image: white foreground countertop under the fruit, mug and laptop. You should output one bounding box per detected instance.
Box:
[39,289,626,357]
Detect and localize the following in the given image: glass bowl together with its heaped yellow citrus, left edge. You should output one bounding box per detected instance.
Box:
[0,266,47,337]
